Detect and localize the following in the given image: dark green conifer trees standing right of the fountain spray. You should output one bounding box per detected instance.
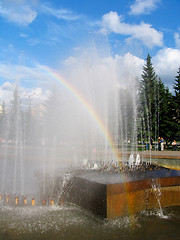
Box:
[138,54,180,144]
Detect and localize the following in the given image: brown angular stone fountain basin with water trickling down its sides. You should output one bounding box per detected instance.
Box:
[64,167,180,218]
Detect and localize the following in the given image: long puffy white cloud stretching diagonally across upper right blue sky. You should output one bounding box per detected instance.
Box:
[102,12,163,48]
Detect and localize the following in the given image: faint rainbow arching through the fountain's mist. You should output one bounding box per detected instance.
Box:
[41,66,117,157]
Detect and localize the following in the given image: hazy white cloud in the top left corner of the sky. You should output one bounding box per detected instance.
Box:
[0,2,37,26]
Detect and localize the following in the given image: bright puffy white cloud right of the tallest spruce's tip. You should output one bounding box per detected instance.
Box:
[152,48,180,88]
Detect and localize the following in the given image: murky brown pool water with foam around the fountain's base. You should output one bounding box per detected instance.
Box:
[0,205,180,240]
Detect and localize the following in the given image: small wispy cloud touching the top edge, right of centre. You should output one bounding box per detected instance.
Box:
[130,0,161,15]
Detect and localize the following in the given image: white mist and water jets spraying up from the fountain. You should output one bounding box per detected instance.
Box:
[0,47,143,199]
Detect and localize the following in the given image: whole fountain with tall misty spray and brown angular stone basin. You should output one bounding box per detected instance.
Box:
[0,48,180,218]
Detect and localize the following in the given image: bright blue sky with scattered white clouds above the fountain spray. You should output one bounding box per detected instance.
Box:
[0,0,180,103]
